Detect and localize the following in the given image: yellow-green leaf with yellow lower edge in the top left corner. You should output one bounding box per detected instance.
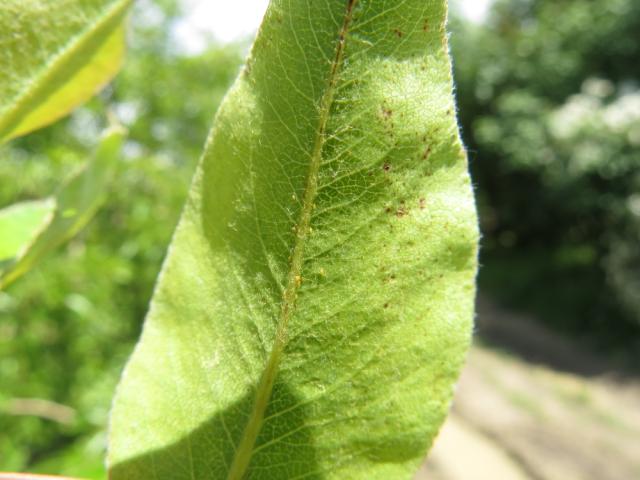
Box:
[0,0,132,143]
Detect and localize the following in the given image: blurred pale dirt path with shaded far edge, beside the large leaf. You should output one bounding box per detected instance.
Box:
[416,300,640,480]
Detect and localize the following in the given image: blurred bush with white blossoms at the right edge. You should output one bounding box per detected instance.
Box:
[549,82,640,318]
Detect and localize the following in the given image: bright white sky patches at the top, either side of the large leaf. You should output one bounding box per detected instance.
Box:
[174,0,492,53]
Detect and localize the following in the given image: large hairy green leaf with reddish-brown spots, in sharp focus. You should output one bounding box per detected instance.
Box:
[108,0,478,480]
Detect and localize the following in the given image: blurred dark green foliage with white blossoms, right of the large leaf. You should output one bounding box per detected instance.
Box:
[453,0,640,352]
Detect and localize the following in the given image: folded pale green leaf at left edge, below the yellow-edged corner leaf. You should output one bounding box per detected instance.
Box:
[0,126,125,289]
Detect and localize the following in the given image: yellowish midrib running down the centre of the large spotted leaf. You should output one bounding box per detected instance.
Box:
[227,0,358,480]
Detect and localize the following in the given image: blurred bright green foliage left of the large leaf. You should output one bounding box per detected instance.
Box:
[0,1,242,478]
